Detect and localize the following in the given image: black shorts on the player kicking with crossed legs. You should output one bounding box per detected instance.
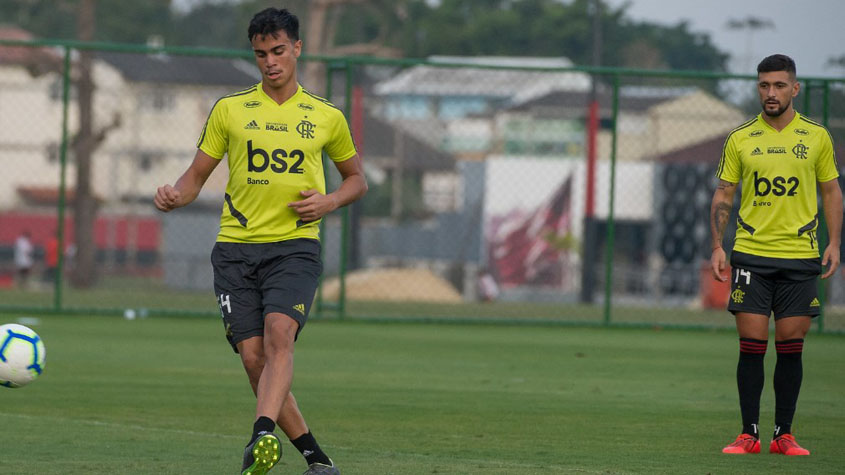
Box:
[211,239,323,353]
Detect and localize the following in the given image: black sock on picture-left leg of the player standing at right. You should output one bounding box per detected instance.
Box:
[736,338,768,439]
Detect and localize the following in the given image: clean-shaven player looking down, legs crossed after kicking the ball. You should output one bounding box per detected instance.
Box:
[154,8,367,475]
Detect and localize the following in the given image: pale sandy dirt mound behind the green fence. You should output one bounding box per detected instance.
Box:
[323,269,462,303]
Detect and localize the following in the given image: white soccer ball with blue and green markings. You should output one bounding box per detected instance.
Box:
[0,323,47,388]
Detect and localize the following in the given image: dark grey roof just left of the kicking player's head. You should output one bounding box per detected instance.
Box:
[97,52,261,87]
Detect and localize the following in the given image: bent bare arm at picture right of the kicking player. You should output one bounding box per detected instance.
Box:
[288,154,368,222]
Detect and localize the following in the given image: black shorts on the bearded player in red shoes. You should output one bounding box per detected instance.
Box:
[728,251,821,320]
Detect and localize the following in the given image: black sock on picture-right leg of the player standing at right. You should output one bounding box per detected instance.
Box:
[774,338,804,437]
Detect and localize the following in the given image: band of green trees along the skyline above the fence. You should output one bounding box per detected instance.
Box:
[0,0,728,73]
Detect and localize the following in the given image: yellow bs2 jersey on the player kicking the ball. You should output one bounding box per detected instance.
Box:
[197,83,356,243]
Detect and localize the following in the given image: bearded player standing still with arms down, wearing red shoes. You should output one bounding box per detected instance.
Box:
[710,54,842,455]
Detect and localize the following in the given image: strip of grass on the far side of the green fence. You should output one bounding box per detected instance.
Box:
[0,276,845,333]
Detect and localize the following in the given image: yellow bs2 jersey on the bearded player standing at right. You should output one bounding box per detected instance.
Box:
[716,113,839,259]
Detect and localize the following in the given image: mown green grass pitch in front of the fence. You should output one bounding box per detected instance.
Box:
[0,315,845,475]
